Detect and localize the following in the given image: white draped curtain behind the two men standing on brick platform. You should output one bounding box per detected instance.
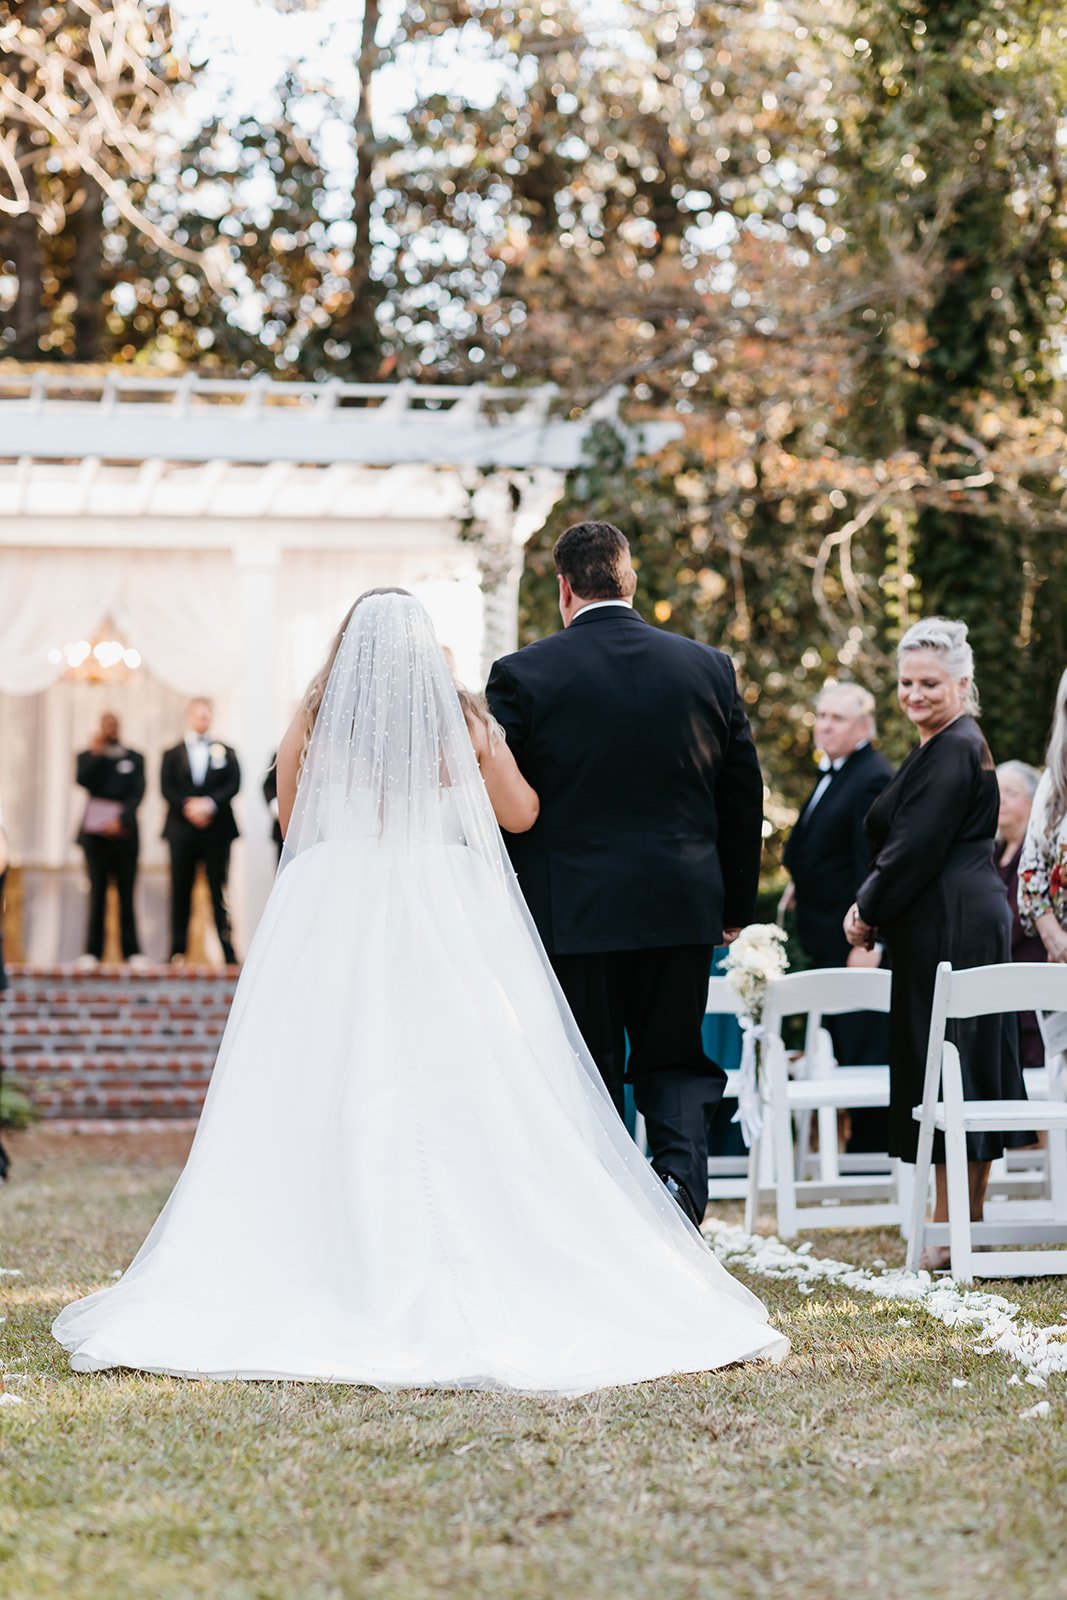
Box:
[0,549,243,963]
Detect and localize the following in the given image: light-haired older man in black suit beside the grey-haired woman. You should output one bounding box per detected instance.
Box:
[781,682,893,1150]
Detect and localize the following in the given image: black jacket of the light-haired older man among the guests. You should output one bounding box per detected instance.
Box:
[784,744,893,966]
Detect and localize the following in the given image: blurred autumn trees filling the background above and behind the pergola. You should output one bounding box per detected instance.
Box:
[0,0,1067,844]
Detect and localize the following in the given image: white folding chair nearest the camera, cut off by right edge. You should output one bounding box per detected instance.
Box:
[907,962,1067,1283]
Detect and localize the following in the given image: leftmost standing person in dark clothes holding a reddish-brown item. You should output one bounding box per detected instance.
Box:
[75,712,144,966]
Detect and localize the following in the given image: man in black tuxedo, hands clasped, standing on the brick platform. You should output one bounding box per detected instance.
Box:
[160,699,242,966]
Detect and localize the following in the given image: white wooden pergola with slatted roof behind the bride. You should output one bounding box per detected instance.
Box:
[0,366,678,939]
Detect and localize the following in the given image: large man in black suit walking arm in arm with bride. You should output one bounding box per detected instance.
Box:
[488,522,763,1222]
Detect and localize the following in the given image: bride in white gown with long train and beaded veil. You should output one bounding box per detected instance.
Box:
[53,589,789,1394]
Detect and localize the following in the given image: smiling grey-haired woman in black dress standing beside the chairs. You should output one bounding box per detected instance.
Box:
[845,618,1032,1267]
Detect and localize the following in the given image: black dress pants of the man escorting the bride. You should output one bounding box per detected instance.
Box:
[550,944,726,1216]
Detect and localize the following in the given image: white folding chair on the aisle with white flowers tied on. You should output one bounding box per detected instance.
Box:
[745,966,907,1238]
